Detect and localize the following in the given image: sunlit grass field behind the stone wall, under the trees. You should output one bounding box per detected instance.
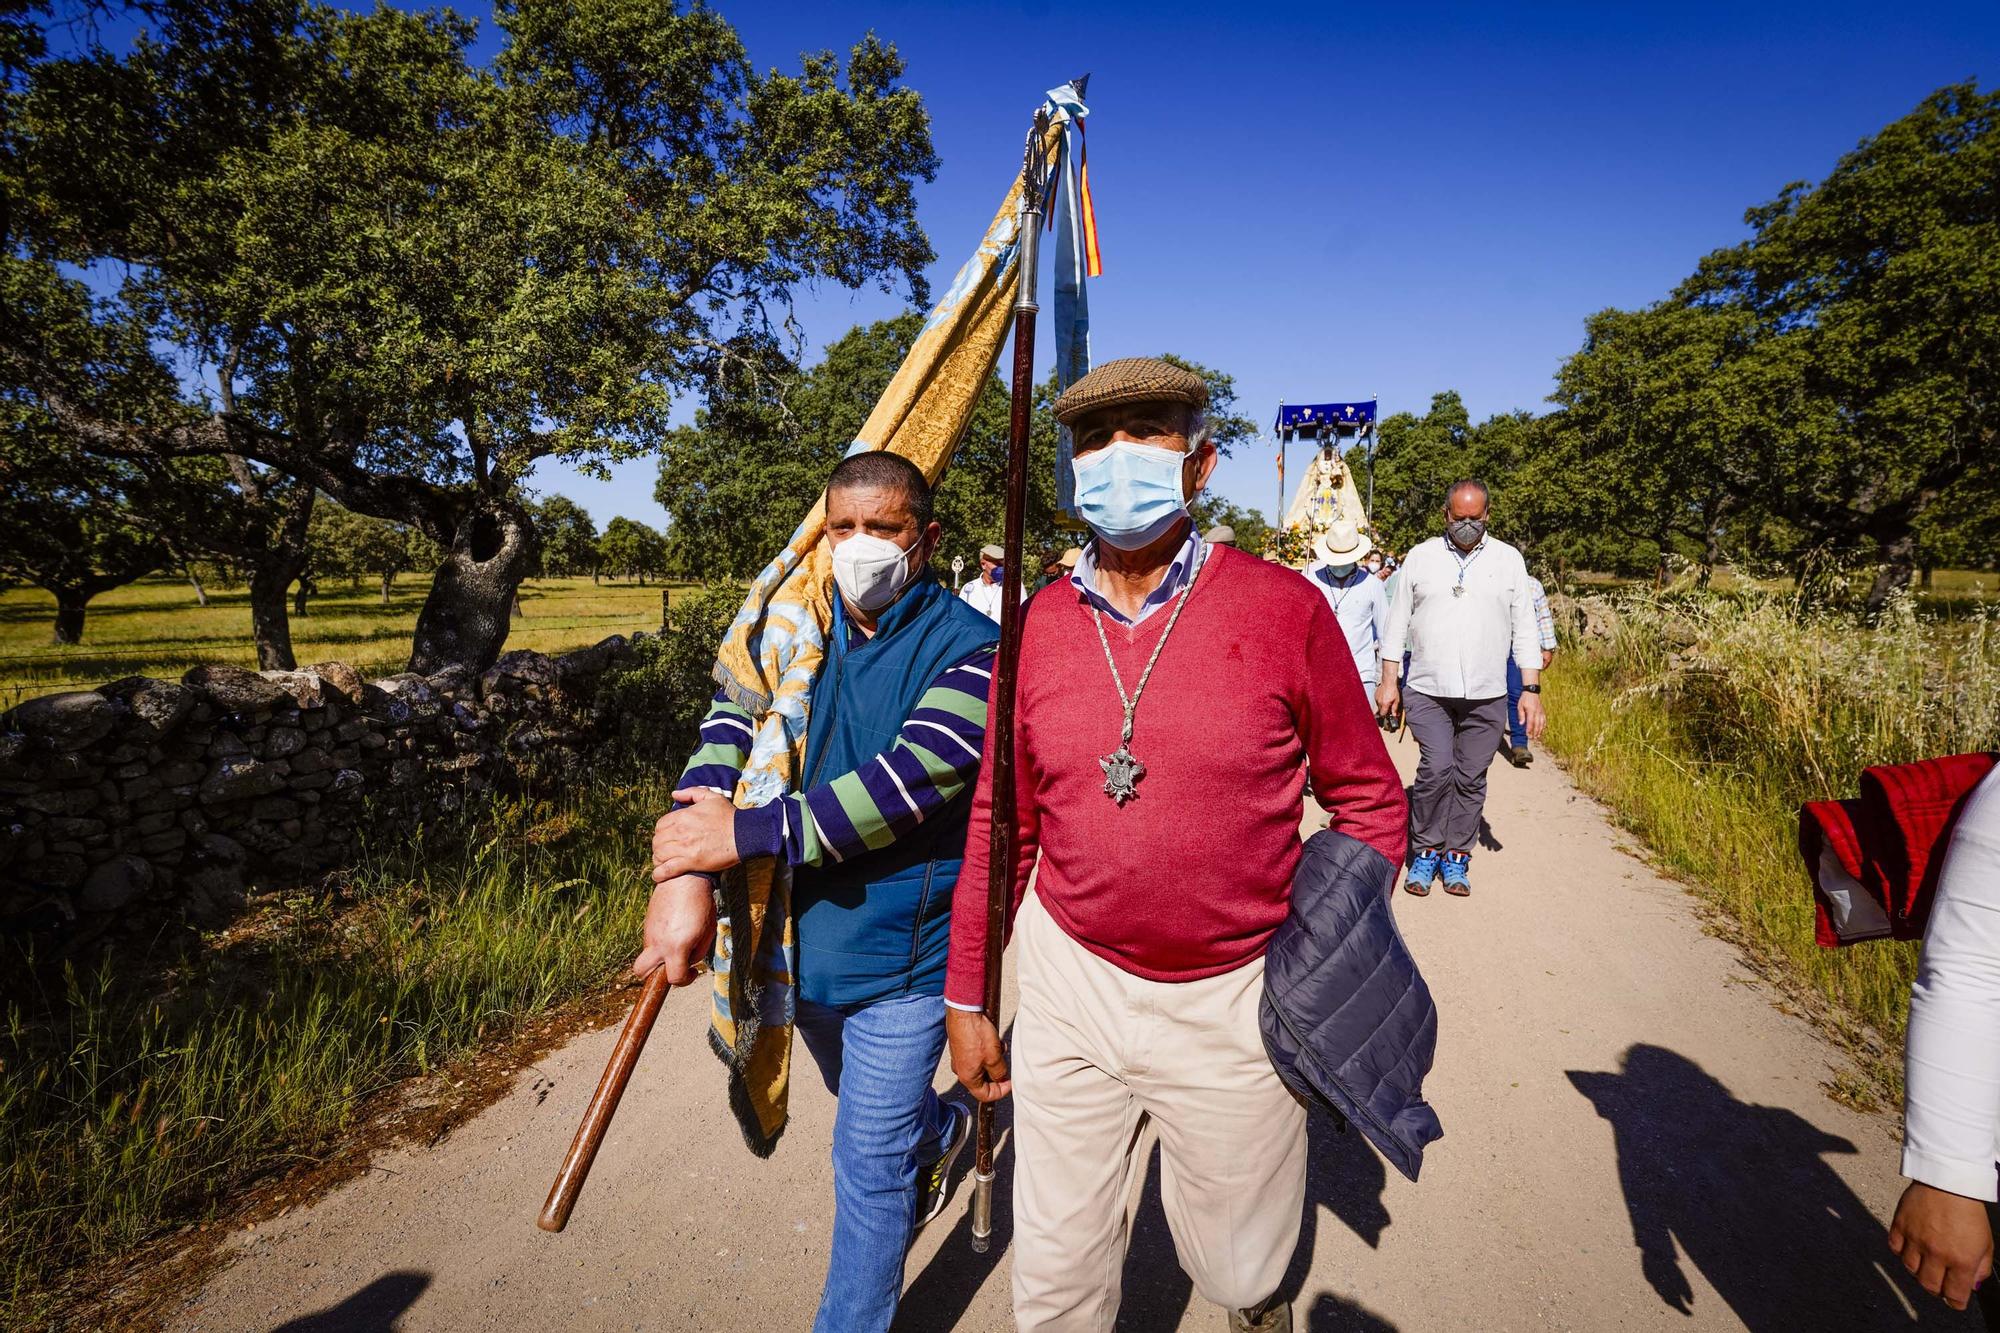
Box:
[0,574,692,709]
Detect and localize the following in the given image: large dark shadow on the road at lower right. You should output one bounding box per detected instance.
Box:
[1568,1045,1976,1333]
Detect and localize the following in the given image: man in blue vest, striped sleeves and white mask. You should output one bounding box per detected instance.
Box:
[632,452,1000,1333]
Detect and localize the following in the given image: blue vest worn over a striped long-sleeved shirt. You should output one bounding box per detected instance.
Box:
[792,570,1000,1007]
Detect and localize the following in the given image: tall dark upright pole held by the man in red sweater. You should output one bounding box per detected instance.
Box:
[972,106,1082,1253]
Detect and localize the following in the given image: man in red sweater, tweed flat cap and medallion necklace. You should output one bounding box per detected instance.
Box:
[944,358,1408,1331]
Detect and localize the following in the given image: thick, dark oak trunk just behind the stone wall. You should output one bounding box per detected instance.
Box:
[410,496,534,677]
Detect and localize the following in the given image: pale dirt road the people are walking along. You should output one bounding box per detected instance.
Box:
[176,743,1974,1333]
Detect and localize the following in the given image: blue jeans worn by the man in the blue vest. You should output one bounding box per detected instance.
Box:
[796,995,952,1333]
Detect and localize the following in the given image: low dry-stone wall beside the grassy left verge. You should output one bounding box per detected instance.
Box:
[0,636,632,933]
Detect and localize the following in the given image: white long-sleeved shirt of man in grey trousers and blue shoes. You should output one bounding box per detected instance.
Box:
[1382,534,1542,699]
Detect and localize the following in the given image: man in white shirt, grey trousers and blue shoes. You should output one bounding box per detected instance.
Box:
[1376,478,1544,899]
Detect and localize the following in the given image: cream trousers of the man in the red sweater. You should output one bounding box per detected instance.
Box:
[1012,895,1306,1333]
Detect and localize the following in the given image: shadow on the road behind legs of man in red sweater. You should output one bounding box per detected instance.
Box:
[1118,1113,1390,1333]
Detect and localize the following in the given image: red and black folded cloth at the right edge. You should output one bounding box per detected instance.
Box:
[1798,753,2000,949]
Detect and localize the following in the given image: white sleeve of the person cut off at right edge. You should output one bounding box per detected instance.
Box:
[1902,769,2000,1201]
